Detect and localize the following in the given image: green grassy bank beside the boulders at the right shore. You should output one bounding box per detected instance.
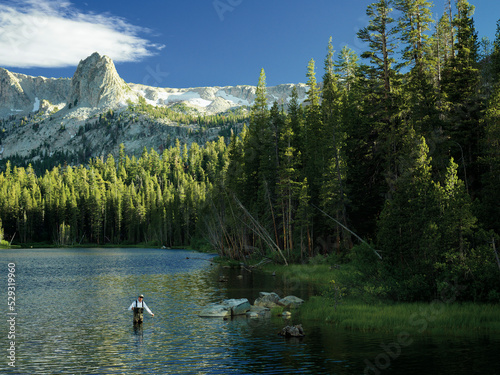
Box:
[264,264,500,334]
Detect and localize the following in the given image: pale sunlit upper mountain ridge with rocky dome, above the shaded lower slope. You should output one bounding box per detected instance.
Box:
[0,52,307,118]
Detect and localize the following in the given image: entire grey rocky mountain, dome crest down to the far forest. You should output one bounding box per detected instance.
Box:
[0,53,307,163]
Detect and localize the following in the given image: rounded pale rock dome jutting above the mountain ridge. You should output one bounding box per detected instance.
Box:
[68,52,130,107]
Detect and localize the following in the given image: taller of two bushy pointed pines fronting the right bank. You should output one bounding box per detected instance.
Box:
[377,138,439,300]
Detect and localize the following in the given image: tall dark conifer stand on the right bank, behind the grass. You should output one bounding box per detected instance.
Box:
[206,0,500,301]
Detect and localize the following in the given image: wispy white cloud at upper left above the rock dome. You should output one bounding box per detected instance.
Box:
[0,0,164,68]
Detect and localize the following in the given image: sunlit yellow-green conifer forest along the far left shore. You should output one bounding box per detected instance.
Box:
[0,138,227,246]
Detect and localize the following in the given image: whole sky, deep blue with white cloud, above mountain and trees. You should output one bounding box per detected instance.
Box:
[0,0,500,87]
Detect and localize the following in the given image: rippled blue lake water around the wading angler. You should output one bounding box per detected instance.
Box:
[0,249,500,375]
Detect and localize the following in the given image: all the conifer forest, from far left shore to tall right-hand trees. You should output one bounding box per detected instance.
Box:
[0,0,500,301]
